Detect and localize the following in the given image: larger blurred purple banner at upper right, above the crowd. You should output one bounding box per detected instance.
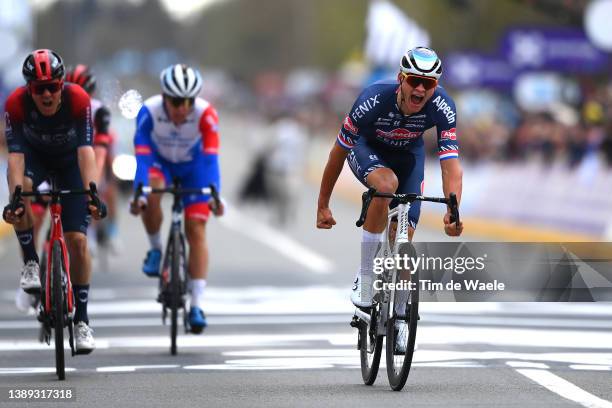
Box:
[501,27,609,73]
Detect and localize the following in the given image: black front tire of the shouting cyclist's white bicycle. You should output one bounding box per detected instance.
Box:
[386,243,419,391]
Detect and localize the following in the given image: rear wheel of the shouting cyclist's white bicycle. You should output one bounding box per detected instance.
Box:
[358,305,383,385]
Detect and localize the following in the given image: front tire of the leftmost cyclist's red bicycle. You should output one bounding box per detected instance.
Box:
[51,241,66,380]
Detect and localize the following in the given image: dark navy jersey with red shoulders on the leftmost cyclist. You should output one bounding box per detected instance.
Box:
[5,84,93,157]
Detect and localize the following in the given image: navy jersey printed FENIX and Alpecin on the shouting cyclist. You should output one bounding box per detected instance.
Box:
[337,81,459,160]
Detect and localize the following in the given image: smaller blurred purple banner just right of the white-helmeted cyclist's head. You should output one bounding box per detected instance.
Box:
[442,52,517,88]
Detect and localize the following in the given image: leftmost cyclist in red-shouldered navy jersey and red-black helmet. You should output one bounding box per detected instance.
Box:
[2,49,106,353]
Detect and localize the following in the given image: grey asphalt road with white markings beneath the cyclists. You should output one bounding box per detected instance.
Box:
[0,130,612,408]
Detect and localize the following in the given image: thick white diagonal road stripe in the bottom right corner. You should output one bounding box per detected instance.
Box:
[516,368,612,408]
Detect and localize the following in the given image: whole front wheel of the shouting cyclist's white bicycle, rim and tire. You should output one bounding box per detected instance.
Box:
[386,243,419,391]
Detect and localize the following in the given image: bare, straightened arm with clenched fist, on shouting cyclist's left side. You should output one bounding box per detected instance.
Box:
[317,143,349,229]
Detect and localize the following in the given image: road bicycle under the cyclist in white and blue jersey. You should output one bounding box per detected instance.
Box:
[134,178,221,355]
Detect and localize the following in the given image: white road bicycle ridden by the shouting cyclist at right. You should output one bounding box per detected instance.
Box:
[351,188,459,391]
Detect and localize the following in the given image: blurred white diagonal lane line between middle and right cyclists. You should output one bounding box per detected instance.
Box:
[219,207,333,274]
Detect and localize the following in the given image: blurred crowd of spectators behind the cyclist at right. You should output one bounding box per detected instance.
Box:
[459,82,612,168]
